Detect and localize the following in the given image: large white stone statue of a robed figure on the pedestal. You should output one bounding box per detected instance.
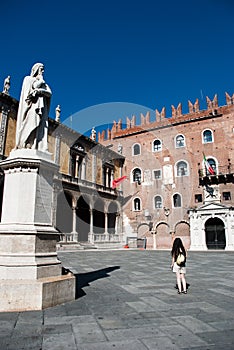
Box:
[15,63,52,151]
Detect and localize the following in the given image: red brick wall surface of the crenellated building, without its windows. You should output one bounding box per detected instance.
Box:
[99,95,234,249]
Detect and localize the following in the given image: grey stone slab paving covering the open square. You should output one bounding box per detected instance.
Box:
[0,250,234,350]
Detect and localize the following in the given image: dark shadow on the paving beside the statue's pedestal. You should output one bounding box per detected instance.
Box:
[75,266,120,299]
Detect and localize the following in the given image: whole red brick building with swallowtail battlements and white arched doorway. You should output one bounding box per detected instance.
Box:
[98,93,234,250]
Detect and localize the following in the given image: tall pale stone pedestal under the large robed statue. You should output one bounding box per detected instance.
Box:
[0,149,75,311]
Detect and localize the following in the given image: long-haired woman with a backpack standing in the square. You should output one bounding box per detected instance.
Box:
[171,238,187,294]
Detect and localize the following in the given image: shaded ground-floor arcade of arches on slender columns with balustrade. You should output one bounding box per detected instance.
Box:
[56,190,122,243]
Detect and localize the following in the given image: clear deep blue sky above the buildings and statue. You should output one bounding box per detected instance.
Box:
[0,0,234,132]
